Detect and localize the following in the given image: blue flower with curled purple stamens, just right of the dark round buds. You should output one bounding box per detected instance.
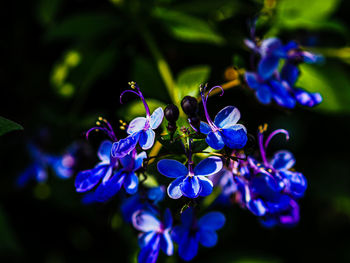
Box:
[200,87,248,150]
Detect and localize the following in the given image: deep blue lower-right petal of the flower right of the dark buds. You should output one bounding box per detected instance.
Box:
[221,125,248,149]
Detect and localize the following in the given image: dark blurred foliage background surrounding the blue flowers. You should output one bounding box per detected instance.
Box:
[0,0,350,263]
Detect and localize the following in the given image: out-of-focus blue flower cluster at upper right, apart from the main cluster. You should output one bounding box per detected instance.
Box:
[245,38,323,108]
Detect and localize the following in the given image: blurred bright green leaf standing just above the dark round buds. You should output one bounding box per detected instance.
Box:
[174,65,210,104]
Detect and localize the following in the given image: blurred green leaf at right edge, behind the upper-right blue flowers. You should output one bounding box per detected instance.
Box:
[297,63,350,113]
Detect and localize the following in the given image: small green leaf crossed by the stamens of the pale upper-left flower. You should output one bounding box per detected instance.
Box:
[117,99,166,121]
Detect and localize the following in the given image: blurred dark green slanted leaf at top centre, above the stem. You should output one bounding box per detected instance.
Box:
[153,8,224,45]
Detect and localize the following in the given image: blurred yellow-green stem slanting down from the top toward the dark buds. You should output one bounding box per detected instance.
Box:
[137,23,178,104]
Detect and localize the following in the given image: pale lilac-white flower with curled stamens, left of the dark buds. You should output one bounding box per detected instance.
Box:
[112,82,164,158]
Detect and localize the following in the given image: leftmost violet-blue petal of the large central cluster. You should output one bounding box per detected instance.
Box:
[75,165,109,192]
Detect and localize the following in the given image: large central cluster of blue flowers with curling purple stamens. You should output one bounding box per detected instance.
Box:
[63,76,314,263]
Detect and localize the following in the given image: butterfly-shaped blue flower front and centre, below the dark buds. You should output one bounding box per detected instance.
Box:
[157,157,223,199]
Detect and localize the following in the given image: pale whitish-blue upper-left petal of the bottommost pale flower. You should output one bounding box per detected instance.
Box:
[132,210,161,233]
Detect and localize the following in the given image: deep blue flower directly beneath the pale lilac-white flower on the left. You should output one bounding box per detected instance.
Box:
[95,150,147,202]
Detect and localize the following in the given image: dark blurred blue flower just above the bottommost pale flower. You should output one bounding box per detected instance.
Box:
[121,186,165,222]
